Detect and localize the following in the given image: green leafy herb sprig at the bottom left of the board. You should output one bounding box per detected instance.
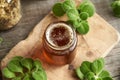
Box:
[2,56,47,80]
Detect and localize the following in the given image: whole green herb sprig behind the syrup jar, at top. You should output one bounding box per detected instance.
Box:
[52,0,95,34]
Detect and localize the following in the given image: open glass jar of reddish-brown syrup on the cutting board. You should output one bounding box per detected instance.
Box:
[42,22,77,65]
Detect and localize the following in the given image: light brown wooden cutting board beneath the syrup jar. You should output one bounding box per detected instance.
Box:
[1,0,120,80]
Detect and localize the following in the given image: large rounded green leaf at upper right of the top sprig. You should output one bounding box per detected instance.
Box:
[78,2,95,17]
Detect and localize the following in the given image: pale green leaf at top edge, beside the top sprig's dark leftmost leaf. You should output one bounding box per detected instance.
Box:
[62,0,75,12]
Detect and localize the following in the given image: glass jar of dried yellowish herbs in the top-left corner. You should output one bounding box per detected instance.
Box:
[0,0,21,30]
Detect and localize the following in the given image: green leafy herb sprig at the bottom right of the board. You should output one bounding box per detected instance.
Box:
[75,58,113,80]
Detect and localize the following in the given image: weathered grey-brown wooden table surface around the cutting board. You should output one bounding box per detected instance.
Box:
[0,0,120,80]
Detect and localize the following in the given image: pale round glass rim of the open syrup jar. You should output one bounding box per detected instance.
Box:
[45,22,76,50]
